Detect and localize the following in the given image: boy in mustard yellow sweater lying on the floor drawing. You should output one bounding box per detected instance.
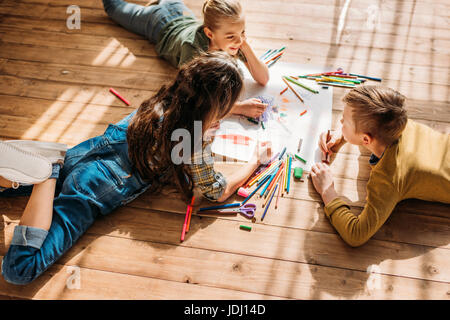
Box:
[311,86,450,247]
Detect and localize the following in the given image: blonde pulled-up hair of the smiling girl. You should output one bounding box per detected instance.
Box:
[202,0,242,30]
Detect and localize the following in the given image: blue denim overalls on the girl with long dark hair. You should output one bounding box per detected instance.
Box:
[2,112,151,284]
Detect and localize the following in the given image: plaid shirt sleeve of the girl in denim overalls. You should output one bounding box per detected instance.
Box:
[188,145,227,201]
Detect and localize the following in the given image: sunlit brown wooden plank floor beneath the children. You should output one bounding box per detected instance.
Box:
[0,0,450,300]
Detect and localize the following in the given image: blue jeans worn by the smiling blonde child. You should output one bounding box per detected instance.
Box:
[103,0,194,43]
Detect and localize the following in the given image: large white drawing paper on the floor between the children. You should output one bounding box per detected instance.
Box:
[211,62,333,171]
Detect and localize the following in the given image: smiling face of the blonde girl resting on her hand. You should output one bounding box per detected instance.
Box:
[205,18,246,56]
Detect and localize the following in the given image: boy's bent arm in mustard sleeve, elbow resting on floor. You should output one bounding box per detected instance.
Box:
[311,163,400,247]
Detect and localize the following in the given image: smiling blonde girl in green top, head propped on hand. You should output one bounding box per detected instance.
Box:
[103,0,269,118]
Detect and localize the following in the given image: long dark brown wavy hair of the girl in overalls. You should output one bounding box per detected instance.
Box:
[127,52,243,200]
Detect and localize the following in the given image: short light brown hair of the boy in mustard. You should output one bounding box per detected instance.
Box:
[342,85,408,145]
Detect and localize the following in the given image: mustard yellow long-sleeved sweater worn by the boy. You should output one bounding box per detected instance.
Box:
[325,120,450,247]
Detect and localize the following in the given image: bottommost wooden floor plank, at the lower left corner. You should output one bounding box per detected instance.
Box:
[0,258,280,300]
